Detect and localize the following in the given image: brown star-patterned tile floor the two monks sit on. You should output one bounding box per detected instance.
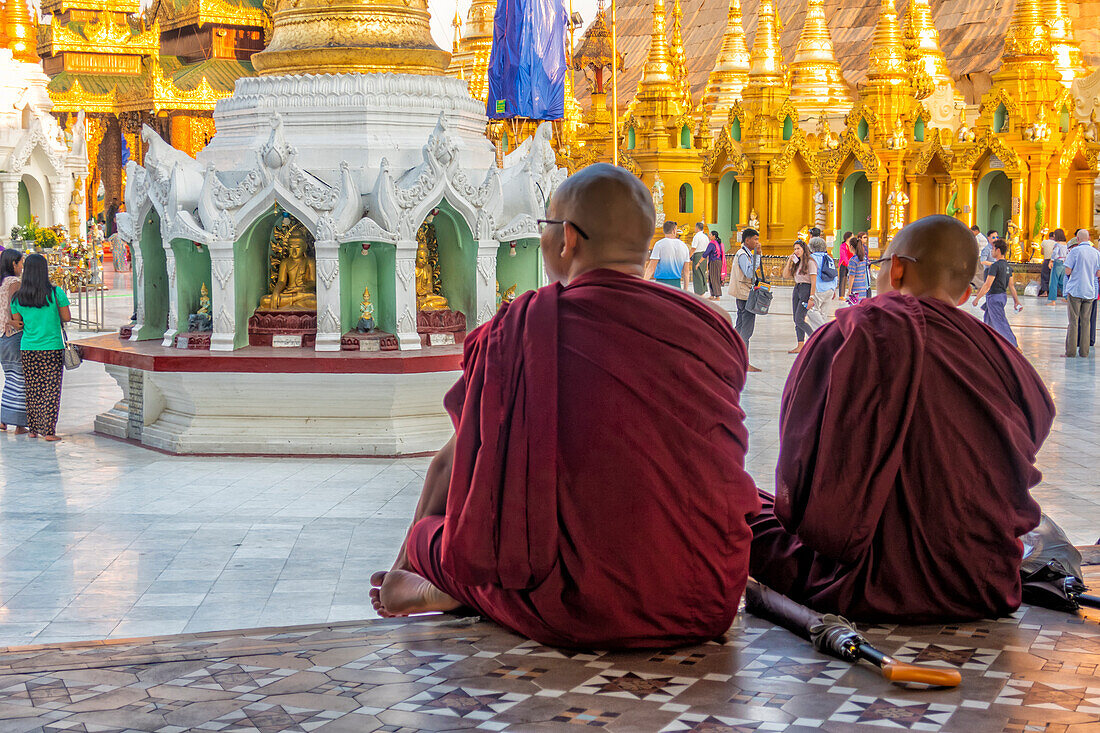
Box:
[0,556,1100,733]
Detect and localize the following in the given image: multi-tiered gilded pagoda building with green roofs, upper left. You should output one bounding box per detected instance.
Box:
[37,0,271,226]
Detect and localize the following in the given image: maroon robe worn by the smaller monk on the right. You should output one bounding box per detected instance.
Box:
[751,293,1054,623]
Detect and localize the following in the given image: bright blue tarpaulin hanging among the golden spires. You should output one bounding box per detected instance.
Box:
[485,0,565,120]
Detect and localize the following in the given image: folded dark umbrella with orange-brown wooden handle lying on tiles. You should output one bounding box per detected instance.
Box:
[745,578,963,687]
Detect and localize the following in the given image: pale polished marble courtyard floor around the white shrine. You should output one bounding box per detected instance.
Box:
[0,278,1100,645]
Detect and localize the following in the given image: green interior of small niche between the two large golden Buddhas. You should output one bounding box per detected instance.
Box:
[340,242,397,333]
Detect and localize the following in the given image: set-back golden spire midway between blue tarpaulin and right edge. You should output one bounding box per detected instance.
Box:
[791,0,851,112]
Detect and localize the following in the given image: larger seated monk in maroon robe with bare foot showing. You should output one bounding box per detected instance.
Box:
[372,164,759,648]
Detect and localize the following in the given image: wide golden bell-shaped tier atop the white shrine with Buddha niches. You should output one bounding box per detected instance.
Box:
[252,0,451,76]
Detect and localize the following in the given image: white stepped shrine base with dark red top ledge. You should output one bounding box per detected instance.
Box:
[77,333,462,456]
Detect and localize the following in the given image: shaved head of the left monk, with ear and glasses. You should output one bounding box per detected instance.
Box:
[541,163,656,282]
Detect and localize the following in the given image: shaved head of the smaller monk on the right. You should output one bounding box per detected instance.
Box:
[887,215,978,300]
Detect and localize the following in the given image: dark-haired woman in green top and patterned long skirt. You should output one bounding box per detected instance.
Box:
[11,254,72,441]
